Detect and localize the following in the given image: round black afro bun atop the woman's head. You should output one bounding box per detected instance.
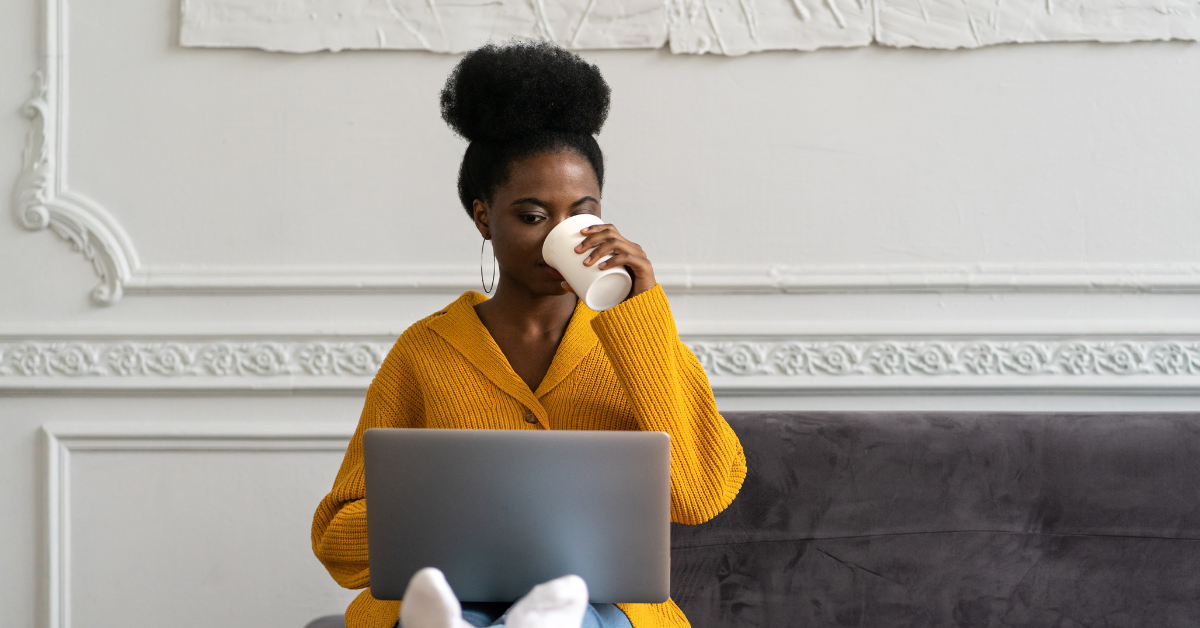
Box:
[442,42,610,142]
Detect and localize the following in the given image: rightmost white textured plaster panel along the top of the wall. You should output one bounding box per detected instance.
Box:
[876,0,1200,48]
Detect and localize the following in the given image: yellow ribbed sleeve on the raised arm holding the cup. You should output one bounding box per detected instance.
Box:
[592,286,746,524]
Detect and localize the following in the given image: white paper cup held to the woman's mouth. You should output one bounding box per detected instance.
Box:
[541,214,634,312]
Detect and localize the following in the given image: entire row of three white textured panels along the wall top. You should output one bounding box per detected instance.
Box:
[180,0,1200,55]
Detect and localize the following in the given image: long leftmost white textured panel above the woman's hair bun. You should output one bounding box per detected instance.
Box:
[180,0,666,53]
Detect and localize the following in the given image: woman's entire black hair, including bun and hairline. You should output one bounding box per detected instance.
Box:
[442,42,610,216]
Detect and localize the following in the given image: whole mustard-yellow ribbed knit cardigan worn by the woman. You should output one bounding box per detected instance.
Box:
[312,286,746,628]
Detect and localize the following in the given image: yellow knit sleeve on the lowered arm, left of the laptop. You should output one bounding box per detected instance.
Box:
[312,336,422,588]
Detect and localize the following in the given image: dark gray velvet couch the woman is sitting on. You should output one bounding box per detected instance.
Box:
[313,413,1200,628]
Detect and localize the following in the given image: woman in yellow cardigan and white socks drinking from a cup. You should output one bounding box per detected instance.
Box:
[312,43,745,628]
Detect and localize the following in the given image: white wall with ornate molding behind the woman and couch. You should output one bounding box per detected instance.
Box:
[7,0,1200,627]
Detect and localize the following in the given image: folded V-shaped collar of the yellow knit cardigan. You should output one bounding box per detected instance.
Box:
[430,291,600,413]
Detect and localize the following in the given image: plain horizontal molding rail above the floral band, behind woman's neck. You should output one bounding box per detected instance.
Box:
[125,263,1200,294]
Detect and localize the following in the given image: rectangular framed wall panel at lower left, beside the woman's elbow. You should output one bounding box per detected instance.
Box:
[46,421,355,628]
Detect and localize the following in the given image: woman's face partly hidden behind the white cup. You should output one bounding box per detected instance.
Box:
[474,149,600,295]
